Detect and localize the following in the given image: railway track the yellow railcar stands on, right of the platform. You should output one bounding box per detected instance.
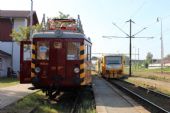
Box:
[109,80,170,113]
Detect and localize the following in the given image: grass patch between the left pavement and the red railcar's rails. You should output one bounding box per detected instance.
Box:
[0,91,58,113]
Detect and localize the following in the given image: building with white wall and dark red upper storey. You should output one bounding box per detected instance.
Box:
[0,10,38,76]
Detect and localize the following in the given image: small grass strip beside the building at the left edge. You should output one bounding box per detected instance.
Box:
[0,77,19,88]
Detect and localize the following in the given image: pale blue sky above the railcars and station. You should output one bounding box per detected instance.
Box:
[0,0,170,59]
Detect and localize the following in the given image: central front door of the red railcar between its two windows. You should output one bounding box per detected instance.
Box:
[49,40,66,81]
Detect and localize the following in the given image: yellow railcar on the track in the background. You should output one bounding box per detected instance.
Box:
[99,55,125,78]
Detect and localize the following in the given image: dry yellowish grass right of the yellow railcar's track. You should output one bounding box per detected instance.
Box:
[125,67,170,95]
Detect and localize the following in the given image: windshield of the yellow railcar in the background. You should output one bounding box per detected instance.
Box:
[106,56,122,64]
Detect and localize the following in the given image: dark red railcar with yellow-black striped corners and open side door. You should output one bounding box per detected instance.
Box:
[20,16,92,97]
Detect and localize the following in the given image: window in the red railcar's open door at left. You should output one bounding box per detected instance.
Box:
[23,44,31,61]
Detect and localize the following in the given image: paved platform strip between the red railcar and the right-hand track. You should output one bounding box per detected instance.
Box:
[92,76,149,113]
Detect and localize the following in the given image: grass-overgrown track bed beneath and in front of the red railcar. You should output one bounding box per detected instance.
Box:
[0,88,95,113]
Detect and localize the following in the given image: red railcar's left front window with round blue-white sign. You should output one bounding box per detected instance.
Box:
[37,41,49,60]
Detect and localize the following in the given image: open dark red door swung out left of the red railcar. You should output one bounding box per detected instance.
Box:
[20,41,31,83]
